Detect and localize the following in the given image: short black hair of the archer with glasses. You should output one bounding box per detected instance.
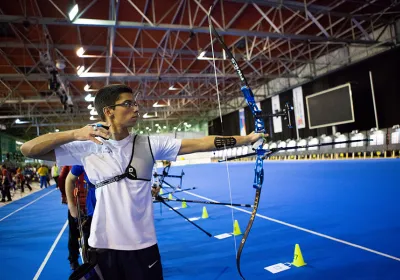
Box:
[94,84,133,121]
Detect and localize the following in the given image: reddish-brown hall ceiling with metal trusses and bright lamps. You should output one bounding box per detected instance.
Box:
[0,0,400,138]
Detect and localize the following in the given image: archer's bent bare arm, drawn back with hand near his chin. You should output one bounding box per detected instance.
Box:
[21,122,110,161]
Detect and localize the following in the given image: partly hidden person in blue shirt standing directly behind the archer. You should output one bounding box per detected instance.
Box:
[65,165,96,270]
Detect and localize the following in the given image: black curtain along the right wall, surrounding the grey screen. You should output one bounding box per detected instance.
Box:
[209,47,400,141]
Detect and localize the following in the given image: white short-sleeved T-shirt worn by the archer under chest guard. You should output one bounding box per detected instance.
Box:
[55,134,181,250]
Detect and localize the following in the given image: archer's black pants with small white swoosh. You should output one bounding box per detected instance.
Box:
[97,244,163,280]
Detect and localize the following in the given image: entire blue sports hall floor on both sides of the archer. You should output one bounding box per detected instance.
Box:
[0,159,400,280]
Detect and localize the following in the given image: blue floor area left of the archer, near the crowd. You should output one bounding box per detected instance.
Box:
[0,187,68,279]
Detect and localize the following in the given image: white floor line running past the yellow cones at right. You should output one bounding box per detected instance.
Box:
[185,191,400,262]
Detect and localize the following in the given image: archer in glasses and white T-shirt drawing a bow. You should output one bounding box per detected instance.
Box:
[21,85,266,280]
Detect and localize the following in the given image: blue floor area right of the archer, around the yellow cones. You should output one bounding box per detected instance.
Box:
[156,160,400,279]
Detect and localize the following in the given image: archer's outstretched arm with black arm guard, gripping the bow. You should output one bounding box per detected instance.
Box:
[178,132,268,155]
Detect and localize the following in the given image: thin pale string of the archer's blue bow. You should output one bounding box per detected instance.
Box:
[208,6,237,256]
